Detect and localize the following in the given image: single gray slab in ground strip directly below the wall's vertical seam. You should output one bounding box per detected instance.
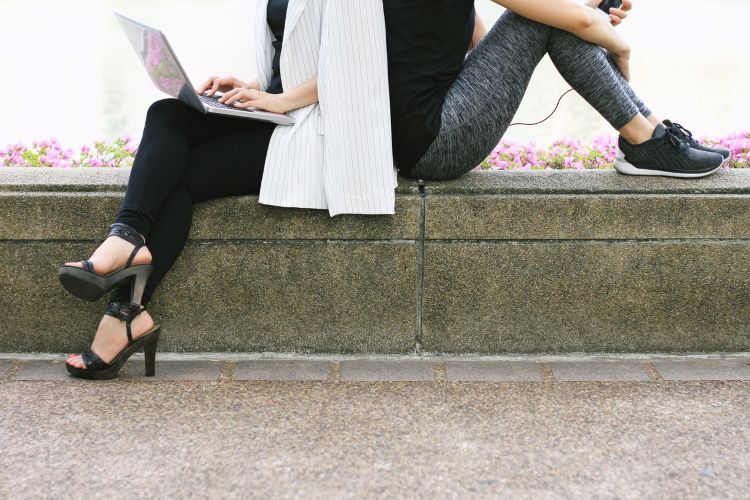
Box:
[339,359,435,382]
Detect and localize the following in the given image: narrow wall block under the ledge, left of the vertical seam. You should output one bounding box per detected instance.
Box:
[0,191,420,240]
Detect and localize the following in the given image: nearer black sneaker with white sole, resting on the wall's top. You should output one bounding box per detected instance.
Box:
[615,125,724,177]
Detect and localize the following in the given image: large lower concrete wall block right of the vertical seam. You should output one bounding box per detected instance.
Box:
[422,240,750,353]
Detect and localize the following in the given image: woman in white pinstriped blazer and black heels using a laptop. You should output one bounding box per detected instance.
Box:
[59,0,396,379]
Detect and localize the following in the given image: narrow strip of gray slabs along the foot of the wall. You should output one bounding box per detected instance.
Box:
[0,355,750,383]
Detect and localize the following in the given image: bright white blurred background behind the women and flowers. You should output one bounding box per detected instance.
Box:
[0,0,750,147]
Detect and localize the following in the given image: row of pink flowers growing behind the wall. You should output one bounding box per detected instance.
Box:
[0,132,750,170]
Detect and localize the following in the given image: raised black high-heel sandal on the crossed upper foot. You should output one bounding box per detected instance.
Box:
[57,222,153,304]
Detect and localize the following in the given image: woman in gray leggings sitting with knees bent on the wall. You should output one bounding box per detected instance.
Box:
[383,0,729,180]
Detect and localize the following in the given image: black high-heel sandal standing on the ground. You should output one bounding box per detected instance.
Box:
[65,302,161,380]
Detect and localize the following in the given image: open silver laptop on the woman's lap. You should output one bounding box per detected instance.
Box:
[115,12,294,125]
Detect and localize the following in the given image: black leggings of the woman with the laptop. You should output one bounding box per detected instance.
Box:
[110,99,275,305]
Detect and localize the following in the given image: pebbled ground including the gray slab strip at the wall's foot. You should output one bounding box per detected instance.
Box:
[0,356,750,498]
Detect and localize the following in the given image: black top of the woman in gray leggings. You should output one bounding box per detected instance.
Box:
[383,0,476,171]
